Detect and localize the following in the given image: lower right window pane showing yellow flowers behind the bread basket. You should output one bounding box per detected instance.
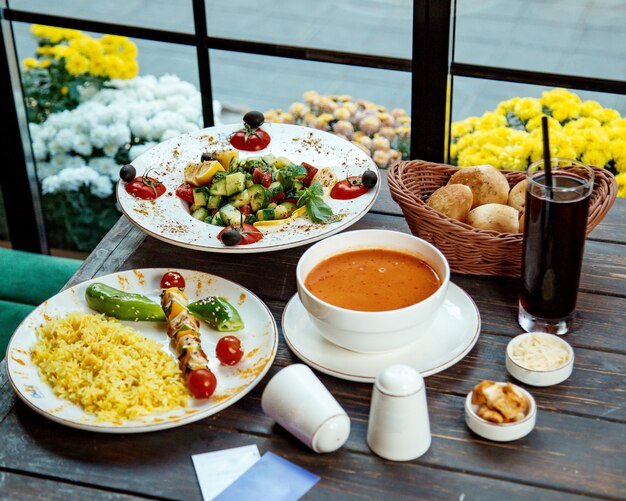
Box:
[450,78,626,174]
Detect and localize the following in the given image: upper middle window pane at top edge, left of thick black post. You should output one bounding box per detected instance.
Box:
[205,0,413,59]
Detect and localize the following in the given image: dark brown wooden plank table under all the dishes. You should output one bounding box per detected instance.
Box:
[0,174,626,500]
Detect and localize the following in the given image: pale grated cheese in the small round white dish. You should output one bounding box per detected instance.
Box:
[510,333,570,371]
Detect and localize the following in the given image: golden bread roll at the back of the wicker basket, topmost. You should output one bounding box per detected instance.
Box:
[448,165,509,209]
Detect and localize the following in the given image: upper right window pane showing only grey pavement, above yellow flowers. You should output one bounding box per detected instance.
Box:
[455,0,626,80]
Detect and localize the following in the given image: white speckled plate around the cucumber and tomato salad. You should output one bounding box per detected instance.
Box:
[117,123,381,253]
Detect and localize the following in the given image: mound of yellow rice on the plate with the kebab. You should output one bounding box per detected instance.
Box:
[31,313,189,421]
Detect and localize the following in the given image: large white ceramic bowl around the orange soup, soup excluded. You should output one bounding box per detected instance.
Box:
[296,230,450,353]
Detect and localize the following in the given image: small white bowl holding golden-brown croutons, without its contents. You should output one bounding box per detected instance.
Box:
[465,383,537,442]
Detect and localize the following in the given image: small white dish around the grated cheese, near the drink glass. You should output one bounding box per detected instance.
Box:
[505,332,574,386]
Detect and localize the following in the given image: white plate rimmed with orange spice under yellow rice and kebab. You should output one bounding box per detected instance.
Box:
[6,268,278,433]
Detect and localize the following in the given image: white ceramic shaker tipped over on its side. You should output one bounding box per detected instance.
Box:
[261,364,350,453]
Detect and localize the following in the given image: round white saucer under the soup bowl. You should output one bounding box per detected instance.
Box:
[282,283,480,383]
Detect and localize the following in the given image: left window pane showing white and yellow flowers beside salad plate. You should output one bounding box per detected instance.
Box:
[14,23,202,252]
